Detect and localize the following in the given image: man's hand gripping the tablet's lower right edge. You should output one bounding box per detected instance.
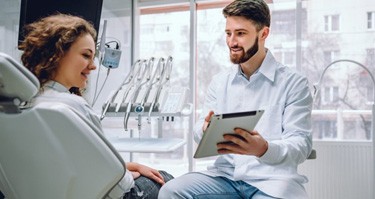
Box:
[217,128,268,157]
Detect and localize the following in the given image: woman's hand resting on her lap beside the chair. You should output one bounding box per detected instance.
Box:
[126,162,165,185]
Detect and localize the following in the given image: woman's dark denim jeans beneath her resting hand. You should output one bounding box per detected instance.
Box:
[123,171,173,199]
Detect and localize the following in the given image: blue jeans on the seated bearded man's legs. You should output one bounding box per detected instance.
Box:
[158,173,273,199]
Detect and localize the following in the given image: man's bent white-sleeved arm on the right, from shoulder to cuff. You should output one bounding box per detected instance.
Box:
[260,78,312,164]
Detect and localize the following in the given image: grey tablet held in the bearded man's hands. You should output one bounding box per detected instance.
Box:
[194,110,264,158]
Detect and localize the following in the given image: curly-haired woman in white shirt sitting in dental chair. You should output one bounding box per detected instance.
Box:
[19,14,173,198]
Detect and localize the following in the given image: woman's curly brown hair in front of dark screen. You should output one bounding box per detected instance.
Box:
[19,13,97,95]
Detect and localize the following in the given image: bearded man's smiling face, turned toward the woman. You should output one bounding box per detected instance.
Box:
[225,16,259,64]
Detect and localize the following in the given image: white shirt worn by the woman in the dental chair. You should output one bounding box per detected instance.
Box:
[32,81,134,198]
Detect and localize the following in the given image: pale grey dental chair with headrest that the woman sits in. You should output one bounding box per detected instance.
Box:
[0,53,125,199]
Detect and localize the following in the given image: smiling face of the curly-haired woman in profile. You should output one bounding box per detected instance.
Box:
[54,34,96,89]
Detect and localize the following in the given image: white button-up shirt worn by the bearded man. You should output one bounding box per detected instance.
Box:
[195,50,312,199]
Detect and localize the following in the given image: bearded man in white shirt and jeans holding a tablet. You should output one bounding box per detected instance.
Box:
[159,0,312,199]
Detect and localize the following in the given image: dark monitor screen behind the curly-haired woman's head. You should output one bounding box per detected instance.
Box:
[18,0,103,44]
